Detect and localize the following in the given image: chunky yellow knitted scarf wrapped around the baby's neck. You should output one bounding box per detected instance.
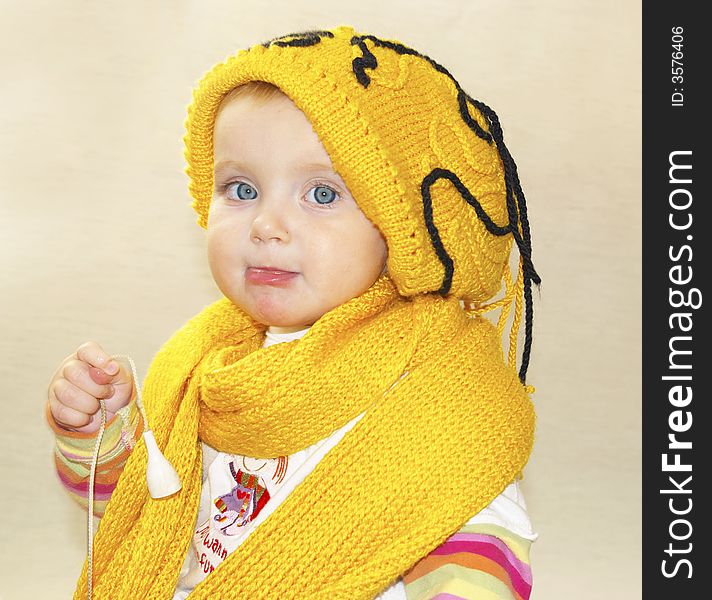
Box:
[75,275,534,600]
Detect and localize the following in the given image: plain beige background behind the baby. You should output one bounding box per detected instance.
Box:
[0,0,641,600]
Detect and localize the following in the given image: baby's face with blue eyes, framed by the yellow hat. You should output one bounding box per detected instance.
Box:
[208,95,387,330]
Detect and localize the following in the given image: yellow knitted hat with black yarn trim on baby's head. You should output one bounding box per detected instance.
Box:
[179,26,540,381]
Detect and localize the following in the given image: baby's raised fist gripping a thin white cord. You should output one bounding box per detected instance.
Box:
[47,342,134,433]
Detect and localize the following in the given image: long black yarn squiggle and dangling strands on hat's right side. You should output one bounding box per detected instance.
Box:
[351,35,541,383]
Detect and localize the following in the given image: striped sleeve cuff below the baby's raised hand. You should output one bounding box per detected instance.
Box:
[46,400,143,517]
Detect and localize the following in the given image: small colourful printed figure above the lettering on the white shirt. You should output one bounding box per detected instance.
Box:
[213,462,270,535]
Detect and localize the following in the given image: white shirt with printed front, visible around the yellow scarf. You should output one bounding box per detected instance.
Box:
[173,327,537,600]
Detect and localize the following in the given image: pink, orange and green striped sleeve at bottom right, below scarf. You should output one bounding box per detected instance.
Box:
[403,523,532,600]
